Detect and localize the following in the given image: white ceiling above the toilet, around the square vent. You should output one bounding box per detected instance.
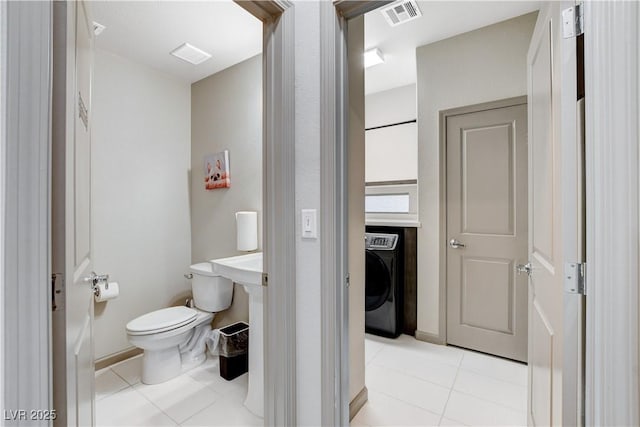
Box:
[91,0,262,83]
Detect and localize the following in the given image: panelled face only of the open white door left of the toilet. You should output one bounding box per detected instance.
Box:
[67,2,95,426]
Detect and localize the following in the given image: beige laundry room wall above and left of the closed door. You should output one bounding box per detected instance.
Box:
[416,13,537,338]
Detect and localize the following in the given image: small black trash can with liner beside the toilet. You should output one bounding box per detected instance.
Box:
[218,322,249,381]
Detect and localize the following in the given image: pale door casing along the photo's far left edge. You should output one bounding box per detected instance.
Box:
[0,2,54,422]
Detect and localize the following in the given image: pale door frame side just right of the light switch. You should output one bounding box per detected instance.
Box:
[320,0,391,426]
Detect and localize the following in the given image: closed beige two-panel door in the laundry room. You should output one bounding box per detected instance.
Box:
[446,103,527,361]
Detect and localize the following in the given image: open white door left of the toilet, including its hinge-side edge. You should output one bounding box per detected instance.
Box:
[52,2,95,426]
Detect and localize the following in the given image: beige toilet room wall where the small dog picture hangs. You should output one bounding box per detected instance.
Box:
[191,55,262,326]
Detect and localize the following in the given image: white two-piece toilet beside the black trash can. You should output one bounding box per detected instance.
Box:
[127,262,233,384]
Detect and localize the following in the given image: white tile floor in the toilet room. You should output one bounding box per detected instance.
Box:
[96,356,263,427]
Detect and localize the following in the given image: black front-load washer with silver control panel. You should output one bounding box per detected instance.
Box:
[365,233,404,338]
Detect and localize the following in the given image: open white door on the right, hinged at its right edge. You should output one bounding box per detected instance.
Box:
[527,2,581,426]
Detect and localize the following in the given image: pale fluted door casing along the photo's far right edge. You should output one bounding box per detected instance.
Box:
[584,1,640,425]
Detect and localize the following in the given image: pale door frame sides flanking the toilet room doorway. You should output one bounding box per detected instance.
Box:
[0,0,304,425]
